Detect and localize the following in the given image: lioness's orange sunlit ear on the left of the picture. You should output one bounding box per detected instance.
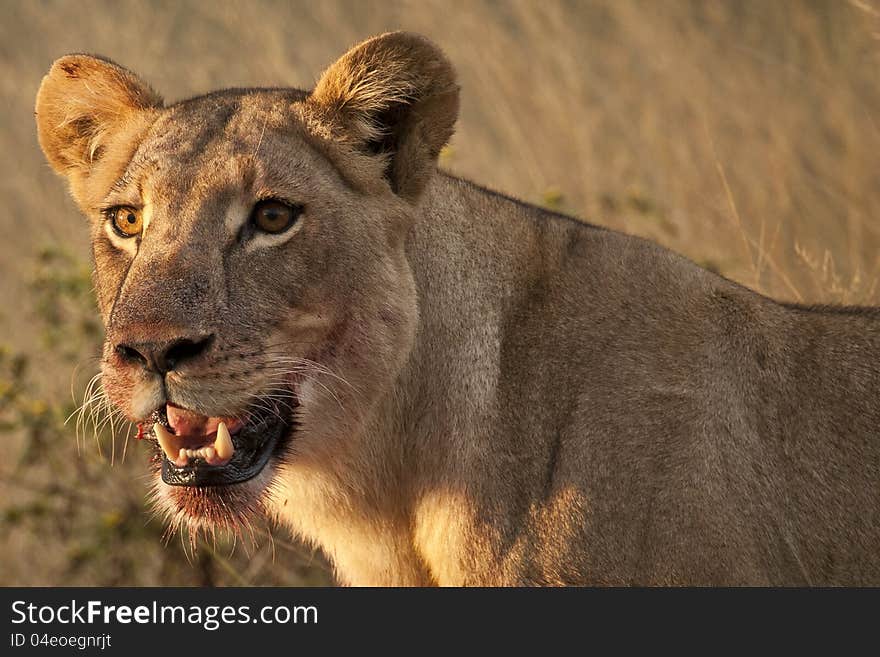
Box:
[35,55,162,202]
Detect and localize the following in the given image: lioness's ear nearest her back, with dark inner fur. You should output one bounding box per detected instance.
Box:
[306,32,458,199]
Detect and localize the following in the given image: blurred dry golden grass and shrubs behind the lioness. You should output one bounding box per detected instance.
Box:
[0,0,880,585]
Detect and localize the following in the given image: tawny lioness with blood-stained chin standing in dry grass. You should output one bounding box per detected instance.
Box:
[36,32,880,585]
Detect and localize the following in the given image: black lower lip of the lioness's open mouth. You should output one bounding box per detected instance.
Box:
[159,398,294,487]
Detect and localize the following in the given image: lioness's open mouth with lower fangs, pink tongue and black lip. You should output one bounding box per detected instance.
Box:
[144,397,296,486]
